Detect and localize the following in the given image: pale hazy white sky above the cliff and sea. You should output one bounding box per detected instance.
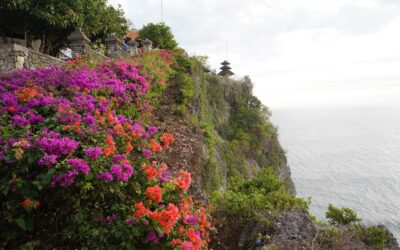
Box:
[110,0,400,108]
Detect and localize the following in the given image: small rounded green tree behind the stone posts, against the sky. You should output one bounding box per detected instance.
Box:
[139,23,178,49]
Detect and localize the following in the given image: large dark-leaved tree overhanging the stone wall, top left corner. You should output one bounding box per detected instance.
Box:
[0,0,128,53]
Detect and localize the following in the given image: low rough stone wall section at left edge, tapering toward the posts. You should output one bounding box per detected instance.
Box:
[0,44,65,73]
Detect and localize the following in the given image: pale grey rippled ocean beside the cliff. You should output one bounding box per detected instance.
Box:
[272,104,400,240]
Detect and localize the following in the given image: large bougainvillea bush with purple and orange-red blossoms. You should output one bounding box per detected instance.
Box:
[0,58,210,249]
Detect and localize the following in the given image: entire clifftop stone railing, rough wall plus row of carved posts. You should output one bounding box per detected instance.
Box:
[0,28,153,73]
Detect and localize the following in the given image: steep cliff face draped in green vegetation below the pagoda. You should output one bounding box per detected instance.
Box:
[190,68,295,194]
